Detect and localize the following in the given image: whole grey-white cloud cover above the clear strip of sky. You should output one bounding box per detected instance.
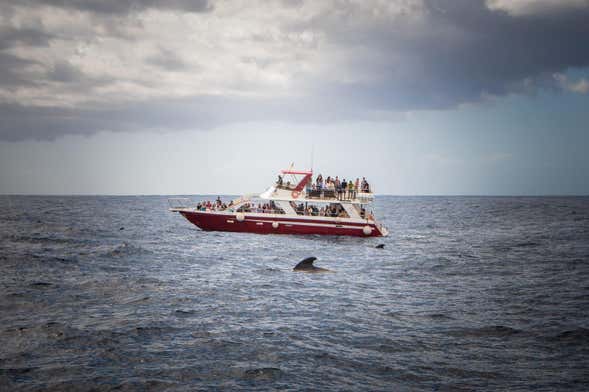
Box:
[0,0,589,140]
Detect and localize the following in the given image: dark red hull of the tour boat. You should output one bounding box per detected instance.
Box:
[179,211,383,237]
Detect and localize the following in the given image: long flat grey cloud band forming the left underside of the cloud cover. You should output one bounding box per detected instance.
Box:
[0,95,382,141]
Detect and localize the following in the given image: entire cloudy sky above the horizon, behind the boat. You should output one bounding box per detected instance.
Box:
[0,0,589,195]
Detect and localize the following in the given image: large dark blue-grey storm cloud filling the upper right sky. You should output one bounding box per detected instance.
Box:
[306,0,589,110]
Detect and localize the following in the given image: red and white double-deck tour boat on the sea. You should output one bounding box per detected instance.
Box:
[169,169,388,237]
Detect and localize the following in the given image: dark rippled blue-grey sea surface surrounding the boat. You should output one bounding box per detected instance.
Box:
[0,196,589,391]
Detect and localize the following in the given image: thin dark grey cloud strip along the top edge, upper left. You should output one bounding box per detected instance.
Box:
[21,0,212,15]
